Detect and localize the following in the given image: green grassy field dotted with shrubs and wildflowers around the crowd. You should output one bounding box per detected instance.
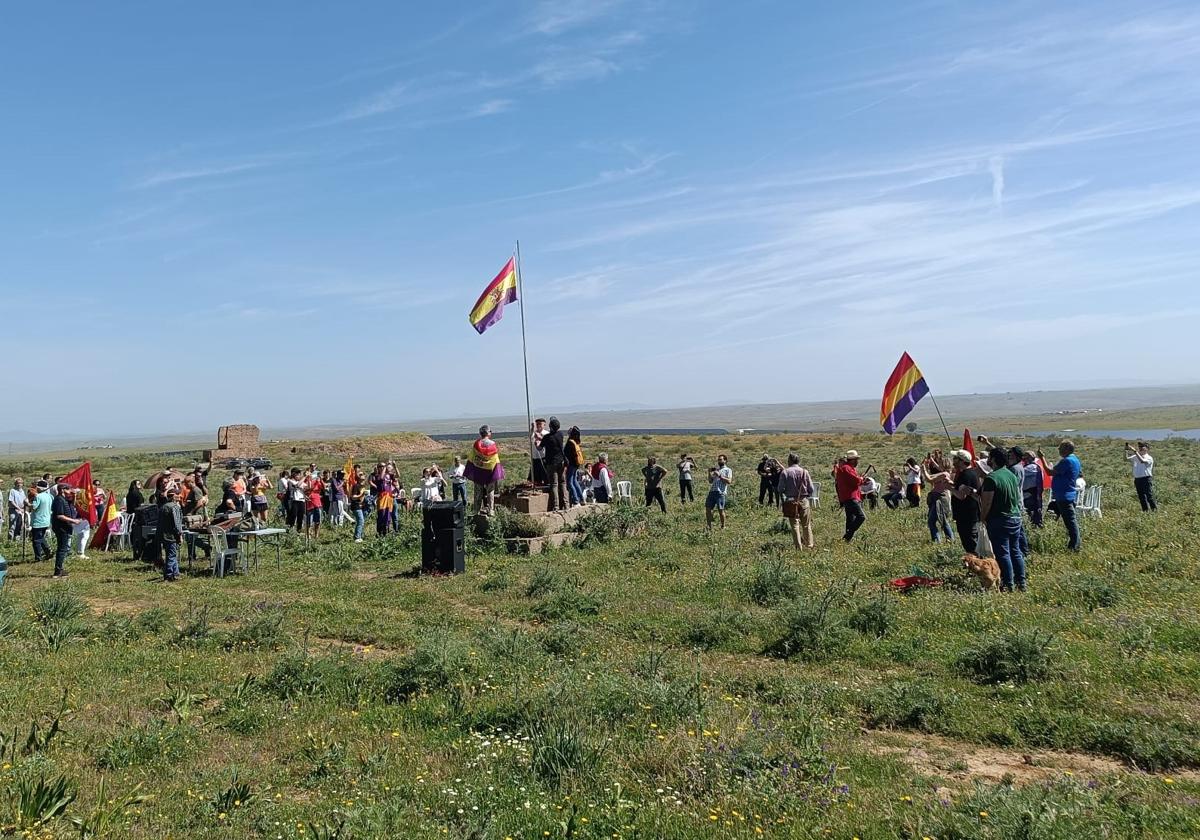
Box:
[0,434,1200,840]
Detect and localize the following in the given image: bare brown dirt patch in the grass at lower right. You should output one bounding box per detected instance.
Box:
[865,731,1200,785]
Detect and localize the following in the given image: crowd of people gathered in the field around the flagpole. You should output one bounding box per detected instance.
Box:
[0,427,1157,589]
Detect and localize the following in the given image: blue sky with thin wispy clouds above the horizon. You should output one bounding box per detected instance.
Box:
[0,0,1200,433]
